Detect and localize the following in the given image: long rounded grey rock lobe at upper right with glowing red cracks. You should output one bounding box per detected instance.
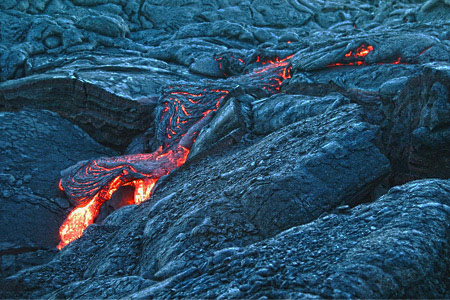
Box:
[292,31,444,72]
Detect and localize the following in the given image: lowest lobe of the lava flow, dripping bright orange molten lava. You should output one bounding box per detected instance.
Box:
[57,145,189,249]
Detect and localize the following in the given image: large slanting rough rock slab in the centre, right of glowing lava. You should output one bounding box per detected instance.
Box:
[2,104,389,298]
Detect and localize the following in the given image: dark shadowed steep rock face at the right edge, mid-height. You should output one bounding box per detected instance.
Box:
[385,63,450,180]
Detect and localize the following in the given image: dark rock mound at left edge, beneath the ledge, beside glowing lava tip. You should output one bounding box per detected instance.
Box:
[0,110,113,276]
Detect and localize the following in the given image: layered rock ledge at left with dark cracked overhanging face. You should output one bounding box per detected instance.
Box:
[0,55,190,149]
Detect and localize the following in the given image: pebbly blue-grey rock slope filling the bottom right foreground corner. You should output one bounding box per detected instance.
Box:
[128,180,450,299]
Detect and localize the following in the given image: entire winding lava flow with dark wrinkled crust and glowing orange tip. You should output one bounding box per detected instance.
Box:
[57,56,292,249]
